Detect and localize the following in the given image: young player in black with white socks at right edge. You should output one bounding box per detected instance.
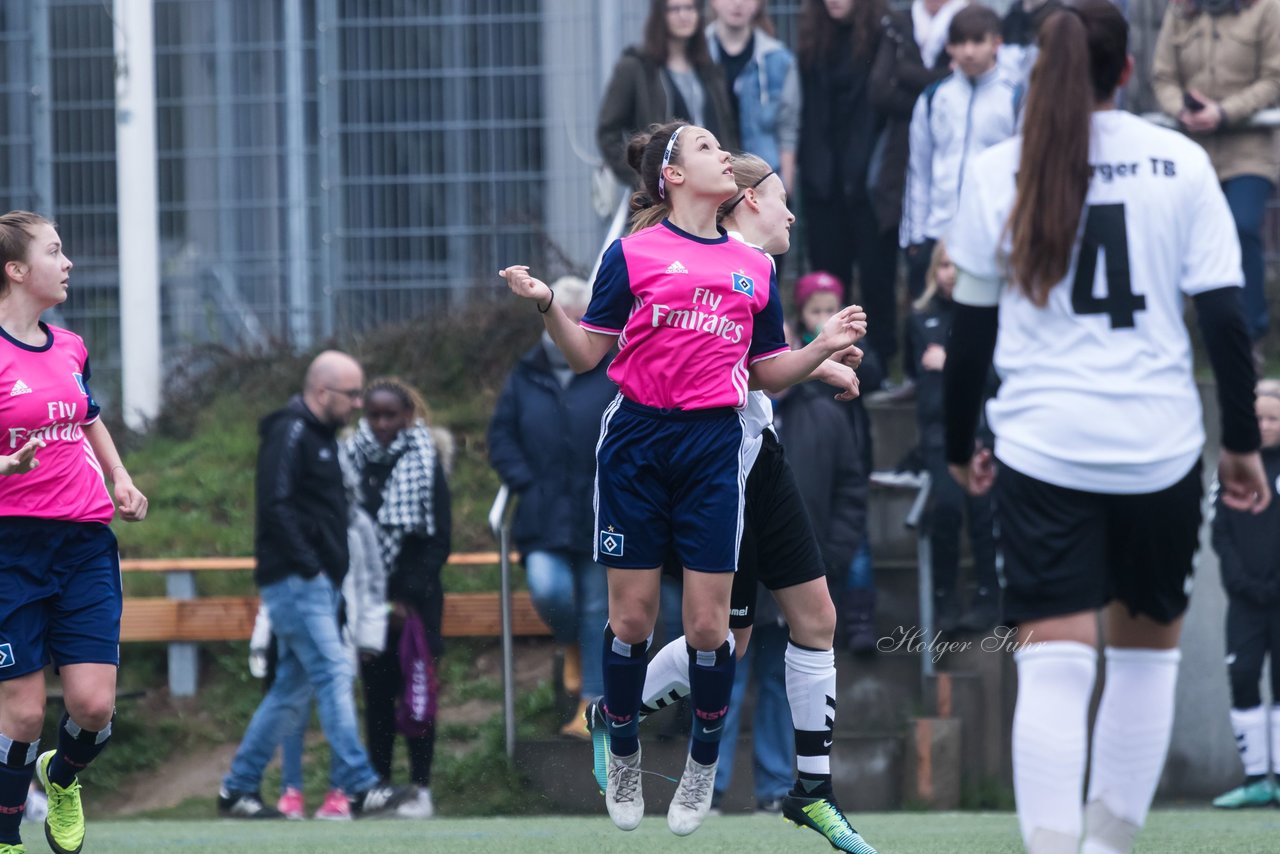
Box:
[1213,380,1280,809]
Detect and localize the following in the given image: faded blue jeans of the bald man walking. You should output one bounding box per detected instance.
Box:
[223,572,378,794]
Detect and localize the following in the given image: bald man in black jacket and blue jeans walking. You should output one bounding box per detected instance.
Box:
[218,351,416,818]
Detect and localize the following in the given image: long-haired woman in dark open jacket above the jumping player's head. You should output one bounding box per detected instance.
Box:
[595,0,739,188]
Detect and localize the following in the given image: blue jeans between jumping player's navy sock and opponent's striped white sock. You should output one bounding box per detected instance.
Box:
[714,622,795,802]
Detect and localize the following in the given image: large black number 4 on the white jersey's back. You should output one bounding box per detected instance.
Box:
[1071,205,1147,329]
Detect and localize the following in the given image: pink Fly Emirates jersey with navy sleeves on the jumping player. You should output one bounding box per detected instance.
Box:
[582,220,787,410]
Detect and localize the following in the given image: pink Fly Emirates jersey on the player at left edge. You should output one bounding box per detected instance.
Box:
[0,324,115,524]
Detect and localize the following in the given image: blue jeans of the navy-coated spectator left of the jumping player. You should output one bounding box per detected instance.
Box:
[525,552,609,697]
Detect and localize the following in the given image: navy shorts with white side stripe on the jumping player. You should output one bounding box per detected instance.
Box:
[595,394,746,572]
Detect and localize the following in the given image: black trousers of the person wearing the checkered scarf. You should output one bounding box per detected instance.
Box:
[360,614,439,787]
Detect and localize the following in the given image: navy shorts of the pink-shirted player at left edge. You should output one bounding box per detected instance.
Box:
[0,517,124,681]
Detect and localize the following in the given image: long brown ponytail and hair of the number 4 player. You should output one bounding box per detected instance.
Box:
[1006,0,1129,306]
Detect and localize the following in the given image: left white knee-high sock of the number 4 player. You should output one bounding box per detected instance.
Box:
[1012,640,1097,854]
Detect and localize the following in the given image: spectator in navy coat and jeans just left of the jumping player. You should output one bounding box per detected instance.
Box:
[489,277,618,737]
